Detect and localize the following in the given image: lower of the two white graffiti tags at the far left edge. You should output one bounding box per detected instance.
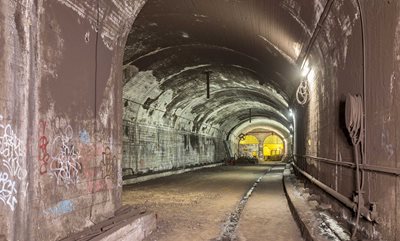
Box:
[0,172,17,211]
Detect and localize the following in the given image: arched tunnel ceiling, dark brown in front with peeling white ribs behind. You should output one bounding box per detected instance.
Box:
[124,0,326,136]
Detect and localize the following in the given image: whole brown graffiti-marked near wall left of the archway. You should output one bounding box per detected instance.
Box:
[0,0,144,240]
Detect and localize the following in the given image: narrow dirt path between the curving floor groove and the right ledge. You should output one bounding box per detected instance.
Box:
[237,167,303,241]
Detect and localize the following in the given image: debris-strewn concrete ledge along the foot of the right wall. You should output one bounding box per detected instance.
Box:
[283,168,350,241]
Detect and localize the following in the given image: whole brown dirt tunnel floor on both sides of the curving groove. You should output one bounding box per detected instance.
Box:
[122,166,301,241]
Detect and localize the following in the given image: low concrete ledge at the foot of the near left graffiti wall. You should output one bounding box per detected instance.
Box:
[91,213,157,241]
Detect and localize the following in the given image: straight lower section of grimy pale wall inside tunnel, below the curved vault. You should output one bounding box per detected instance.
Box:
[122,122,227,173]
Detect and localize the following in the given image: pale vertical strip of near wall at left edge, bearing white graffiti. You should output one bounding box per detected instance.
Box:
[0,0,39,240]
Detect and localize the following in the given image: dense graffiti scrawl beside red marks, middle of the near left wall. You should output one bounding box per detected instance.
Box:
[50,126,81,185]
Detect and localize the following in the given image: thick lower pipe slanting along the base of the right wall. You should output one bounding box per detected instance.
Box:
[292,162,378,222]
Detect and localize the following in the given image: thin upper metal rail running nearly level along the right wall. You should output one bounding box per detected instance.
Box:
[294,155,400,176]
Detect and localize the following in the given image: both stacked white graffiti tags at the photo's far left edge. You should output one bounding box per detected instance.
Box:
[0,115,27,211]
